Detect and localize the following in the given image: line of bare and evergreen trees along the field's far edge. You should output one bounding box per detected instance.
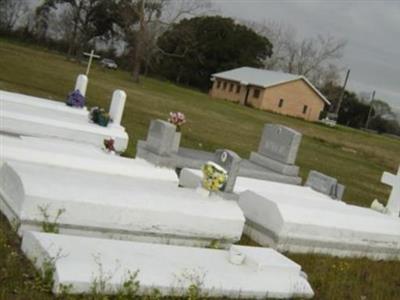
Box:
[0,0,400,134]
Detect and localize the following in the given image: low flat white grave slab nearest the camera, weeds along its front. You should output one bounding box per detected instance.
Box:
[22,232,313,299]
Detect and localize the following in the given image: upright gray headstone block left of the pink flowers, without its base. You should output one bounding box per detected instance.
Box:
[146,120,176,155]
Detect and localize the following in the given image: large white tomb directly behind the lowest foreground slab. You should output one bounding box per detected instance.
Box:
[0,161,244,246]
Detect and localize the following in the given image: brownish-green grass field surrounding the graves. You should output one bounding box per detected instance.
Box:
[0,39,400,299]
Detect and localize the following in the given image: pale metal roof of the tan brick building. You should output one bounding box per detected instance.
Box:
[211,67,331,105]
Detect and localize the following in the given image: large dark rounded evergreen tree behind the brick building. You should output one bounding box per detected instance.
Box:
[158,16,272,89]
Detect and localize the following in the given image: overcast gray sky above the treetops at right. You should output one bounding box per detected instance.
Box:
[212,0,400,109]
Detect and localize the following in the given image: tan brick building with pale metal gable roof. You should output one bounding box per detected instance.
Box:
[210,67,330,121]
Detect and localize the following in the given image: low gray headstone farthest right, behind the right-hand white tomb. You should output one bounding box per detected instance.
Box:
[304,170,345,199]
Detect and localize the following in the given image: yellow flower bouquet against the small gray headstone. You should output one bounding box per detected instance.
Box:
[201,161,228,194]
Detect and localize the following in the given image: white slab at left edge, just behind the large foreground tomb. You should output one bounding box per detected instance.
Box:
[0,134,178,180]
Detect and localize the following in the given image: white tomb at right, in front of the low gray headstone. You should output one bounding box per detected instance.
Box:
[180,170,400,259]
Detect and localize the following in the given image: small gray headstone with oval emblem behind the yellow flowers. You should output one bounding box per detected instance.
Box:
[214,149,241,193]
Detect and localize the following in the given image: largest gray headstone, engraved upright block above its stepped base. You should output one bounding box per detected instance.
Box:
[258,124,301,164]
